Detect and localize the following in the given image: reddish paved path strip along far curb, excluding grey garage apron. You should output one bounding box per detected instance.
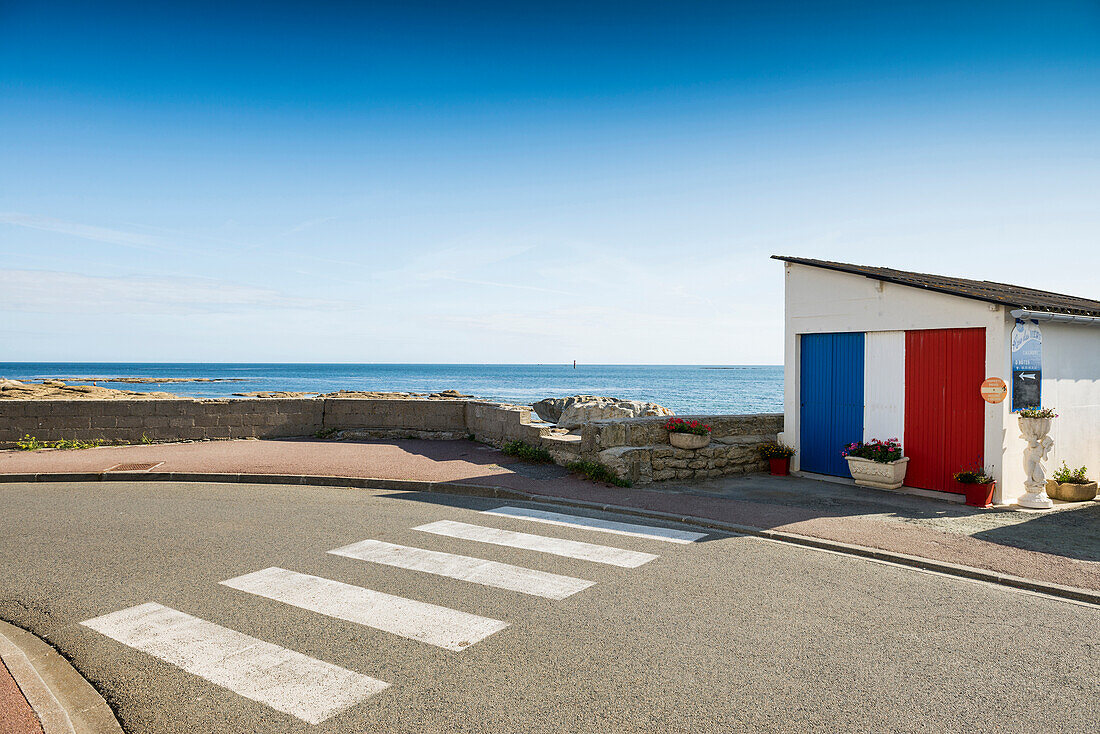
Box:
[0,439,1100,590]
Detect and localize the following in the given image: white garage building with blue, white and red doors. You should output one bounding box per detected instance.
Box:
[774,255,1100,503]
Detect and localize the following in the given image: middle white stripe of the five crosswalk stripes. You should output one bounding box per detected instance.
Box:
[329,540,595,599]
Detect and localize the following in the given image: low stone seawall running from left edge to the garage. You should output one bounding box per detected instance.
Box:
[0,397,783,483]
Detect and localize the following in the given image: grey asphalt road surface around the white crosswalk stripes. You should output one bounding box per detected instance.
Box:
[0,482,1100,734]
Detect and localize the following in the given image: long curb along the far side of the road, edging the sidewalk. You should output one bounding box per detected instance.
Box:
[0,472,1100,606]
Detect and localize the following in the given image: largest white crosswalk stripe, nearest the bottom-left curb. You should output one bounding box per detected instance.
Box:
[80,603,389,724]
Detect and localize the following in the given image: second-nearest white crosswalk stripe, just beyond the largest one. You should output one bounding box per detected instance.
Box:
[221,568,508,650]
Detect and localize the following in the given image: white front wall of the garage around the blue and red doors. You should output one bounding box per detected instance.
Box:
[782,263,1007,484]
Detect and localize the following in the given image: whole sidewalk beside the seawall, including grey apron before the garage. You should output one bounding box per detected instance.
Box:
[0,439,1100,591]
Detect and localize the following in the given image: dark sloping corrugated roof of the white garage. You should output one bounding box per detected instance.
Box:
[772,255,1100,317]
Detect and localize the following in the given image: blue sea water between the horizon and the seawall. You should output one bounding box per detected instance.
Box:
[0,362,783,414]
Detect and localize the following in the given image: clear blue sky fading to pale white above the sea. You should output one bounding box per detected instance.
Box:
[0,0,1100,364]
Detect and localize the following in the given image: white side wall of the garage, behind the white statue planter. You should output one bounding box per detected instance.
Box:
[1000,317,1100,502]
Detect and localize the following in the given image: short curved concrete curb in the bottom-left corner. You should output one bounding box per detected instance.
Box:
[0,621,122,734]
